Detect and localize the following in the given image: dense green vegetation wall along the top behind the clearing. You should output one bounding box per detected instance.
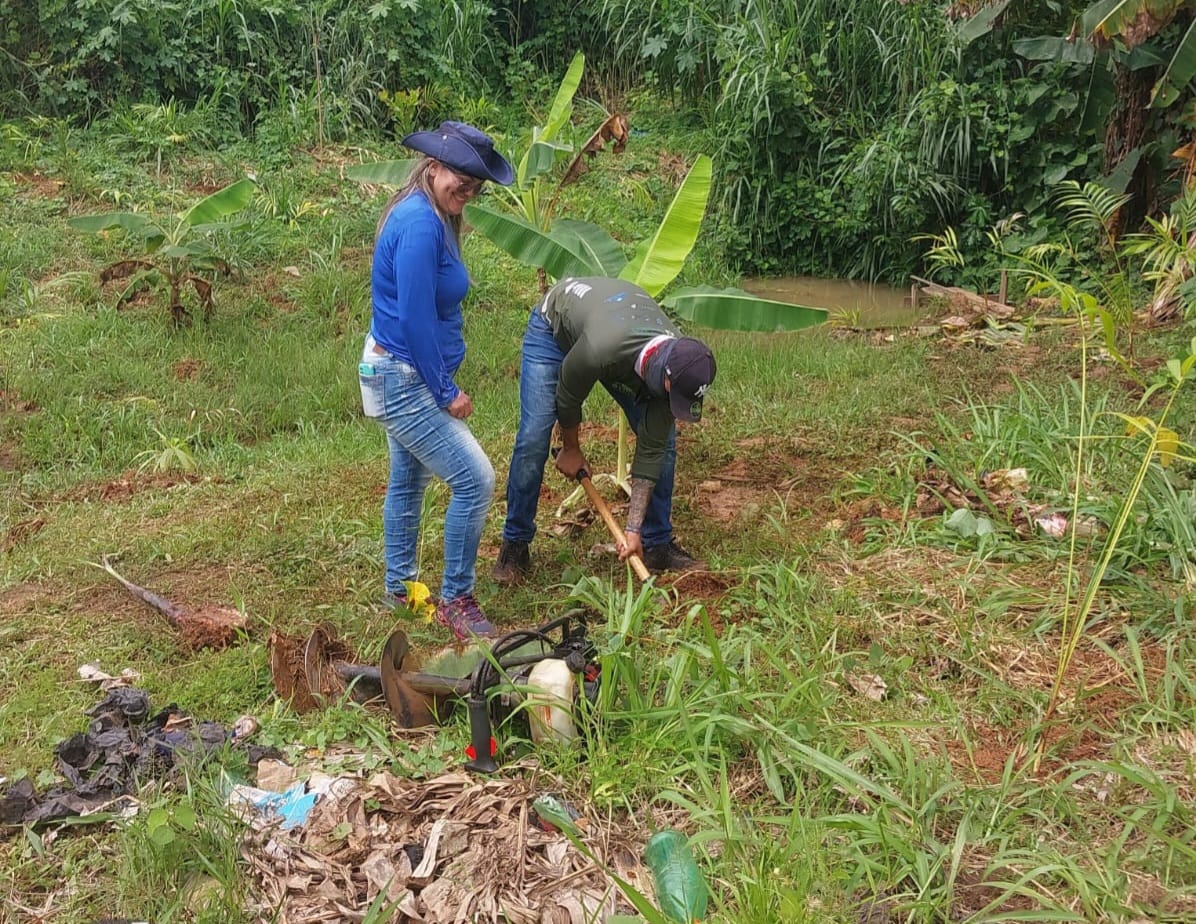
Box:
[0,0,1196,284]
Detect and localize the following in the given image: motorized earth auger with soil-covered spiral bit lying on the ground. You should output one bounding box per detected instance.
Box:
[270,610,600,773]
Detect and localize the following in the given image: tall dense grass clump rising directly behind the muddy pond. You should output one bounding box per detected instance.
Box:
[593,0,1100,281]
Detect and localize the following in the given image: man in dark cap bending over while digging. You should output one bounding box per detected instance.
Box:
[492,277,715,583]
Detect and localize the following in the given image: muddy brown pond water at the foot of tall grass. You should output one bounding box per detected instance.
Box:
[740,276,917,328]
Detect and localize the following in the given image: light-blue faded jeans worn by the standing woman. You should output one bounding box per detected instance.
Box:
[358,337,494,600]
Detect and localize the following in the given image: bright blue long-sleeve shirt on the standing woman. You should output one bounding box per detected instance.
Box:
[370,191,469,408]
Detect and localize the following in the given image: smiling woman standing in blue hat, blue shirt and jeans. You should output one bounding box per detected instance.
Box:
[359,122,514,638]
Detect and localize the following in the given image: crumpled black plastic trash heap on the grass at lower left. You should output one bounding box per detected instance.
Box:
[0,686,268,828]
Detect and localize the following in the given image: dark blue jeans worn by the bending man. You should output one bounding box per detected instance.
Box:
[502,306,677,549]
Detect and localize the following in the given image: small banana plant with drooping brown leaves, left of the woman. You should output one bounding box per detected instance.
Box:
[67,178,254,326]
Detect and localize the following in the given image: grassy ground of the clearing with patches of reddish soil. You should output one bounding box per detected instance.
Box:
[0,122,1196,924]
